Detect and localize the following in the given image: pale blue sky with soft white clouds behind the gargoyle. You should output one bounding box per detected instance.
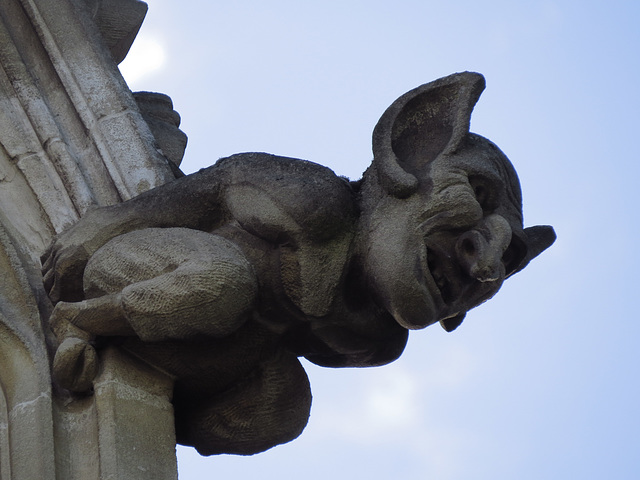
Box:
[121,0,640,480]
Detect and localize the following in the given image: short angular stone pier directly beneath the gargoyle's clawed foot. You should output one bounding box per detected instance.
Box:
[55,347,177,480]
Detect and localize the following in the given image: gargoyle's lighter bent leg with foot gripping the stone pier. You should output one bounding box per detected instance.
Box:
[51,228,258,392]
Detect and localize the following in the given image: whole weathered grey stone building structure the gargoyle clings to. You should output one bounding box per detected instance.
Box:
[0,0,177,480]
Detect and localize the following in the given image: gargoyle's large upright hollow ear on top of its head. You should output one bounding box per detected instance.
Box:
[373,72,485,198]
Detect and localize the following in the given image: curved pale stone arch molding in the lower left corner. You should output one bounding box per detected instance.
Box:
[0,223,55,480]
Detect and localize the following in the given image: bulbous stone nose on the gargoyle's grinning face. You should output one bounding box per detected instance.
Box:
[456,215,511,282]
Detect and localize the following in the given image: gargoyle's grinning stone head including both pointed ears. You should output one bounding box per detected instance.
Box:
[363,72,555,331]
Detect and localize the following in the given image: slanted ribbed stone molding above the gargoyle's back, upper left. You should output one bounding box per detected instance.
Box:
[0,0,173,260]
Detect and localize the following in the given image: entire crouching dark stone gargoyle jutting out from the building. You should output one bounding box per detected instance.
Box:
[43,72,555,455]
